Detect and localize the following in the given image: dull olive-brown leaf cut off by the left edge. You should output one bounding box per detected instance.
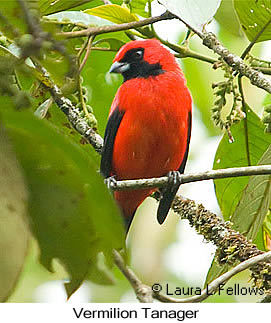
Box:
[0,122,29,302]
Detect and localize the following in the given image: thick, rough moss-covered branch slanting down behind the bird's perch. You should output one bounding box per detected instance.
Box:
[172,196,271,291]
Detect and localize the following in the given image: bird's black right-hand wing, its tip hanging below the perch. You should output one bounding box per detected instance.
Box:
[157,111,191,224]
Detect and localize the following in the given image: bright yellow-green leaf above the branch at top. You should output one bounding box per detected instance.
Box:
[84,4,138,24]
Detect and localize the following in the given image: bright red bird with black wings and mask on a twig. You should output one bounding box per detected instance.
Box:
[101,39,192,230]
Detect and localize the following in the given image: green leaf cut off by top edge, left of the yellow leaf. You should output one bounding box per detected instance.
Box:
[39,0,93,15]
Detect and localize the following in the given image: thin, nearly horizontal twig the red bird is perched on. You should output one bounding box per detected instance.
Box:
[110,165,271,191]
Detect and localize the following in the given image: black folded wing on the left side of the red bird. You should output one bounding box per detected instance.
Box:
[100,107,124,178]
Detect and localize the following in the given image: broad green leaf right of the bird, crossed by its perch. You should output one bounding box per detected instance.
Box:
[213,110,271,221]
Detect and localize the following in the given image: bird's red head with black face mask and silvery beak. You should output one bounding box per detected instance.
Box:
[109,39,179,81]
